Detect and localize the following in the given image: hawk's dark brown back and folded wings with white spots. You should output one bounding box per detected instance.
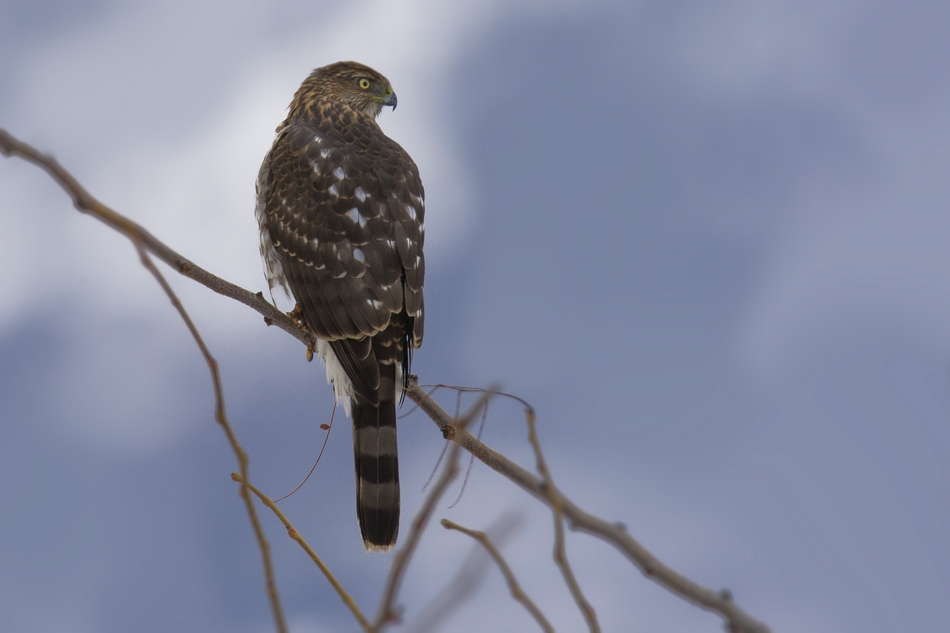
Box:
[258,111,425,395]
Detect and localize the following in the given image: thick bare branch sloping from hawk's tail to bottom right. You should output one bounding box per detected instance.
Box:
[406,381,770,633]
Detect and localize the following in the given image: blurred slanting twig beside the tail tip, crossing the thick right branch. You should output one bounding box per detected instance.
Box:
[373,392,492,631]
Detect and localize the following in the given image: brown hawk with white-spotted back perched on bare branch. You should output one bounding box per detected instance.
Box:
[257,62,425,551]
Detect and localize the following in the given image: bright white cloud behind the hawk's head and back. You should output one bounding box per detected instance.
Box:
[0,0,588,323]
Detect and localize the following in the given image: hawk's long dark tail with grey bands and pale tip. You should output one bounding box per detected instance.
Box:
[353,365,399,552]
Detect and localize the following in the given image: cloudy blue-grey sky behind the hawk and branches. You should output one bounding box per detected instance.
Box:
[0,0,950,633]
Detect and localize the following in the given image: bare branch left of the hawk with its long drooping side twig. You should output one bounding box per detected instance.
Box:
[0,129,290,633]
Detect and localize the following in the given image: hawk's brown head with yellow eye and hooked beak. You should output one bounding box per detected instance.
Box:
[290,62,396,119]
